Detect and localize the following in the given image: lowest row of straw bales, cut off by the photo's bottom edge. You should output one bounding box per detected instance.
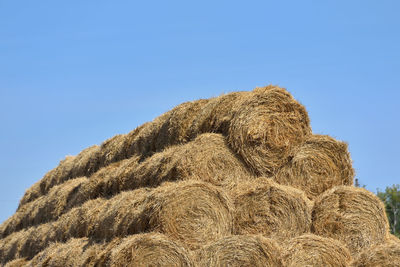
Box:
[5,233,400,267]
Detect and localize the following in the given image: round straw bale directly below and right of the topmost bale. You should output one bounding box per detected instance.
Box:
[274,135,354,199]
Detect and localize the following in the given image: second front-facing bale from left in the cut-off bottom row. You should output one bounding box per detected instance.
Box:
[196,235,283,267]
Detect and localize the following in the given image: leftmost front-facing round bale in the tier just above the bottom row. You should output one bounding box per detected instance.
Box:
[145,181,233,249]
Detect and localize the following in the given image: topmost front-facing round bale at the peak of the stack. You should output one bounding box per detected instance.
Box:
[229,86,311,176]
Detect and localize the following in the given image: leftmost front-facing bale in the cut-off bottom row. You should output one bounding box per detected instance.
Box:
[110,233,194,267]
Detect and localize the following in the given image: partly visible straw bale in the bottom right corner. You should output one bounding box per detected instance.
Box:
[351,242,400,267]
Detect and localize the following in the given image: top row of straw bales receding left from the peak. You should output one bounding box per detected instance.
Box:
[16,86,311,207]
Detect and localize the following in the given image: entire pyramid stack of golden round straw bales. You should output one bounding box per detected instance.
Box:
[0,86,400,266]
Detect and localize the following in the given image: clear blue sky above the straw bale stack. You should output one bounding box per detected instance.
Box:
[0,0,400,222]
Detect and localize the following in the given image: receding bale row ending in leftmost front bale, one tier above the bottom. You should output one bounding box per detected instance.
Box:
[0,181,233,263]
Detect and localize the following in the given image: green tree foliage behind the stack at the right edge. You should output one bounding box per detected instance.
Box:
[377,184,400,237]
